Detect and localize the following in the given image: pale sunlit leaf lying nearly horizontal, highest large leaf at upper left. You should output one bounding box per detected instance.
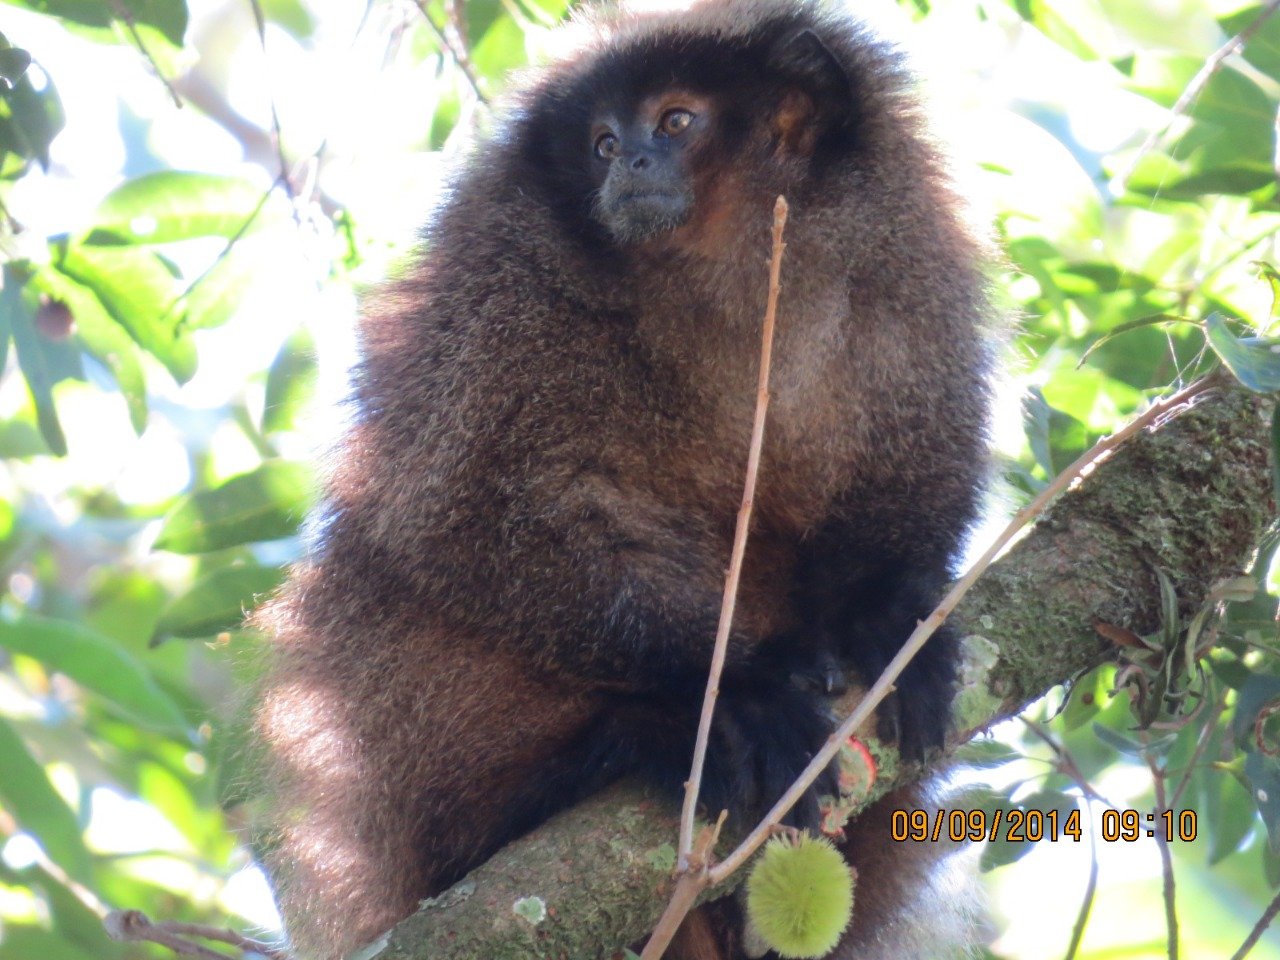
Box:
[84,170,268,244]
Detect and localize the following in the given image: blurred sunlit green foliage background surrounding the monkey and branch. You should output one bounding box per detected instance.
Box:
[0,0,1280,960]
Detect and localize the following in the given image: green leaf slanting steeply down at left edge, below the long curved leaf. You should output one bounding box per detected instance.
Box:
[0,717,90,885]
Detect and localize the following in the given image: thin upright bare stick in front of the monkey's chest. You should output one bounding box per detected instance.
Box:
[678,197,787,872]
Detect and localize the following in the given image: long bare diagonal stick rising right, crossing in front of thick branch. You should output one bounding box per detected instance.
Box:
[710,376,1217,883]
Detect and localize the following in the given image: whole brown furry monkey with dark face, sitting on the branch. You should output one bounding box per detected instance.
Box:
[247,0,989,957]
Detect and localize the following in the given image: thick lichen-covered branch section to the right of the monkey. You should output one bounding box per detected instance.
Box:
[956,388,1274,718]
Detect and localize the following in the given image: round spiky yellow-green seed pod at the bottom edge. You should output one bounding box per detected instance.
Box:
[746,833,854,960]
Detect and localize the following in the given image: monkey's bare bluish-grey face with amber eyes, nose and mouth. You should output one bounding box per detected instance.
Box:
[590,91,714,243]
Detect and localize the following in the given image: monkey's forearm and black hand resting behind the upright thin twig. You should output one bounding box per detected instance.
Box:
[471,471,835,826]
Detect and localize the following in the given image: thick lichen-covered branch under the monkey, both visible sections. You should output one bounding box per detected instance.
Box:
[378,387,1274,960]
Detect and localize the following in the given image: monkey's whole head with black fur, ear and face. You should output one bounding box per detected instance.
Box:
[517,22,858,257]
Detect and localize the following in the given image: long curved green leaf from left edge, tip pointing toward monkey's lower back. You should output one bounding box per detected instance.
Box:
[0,617,187,735]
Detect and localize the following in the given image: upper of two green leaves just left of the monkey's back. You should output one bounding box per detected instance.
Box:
[155,461,314,553]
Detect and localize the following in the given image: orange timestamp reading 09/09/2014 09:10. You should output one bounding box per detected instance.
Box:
[890,806,1197,844]
